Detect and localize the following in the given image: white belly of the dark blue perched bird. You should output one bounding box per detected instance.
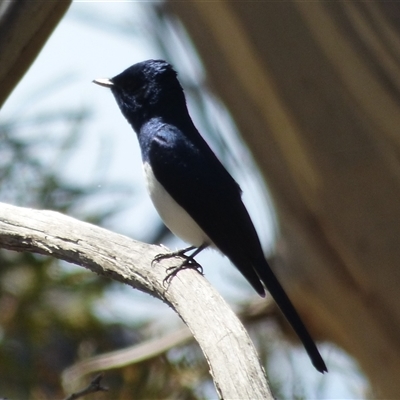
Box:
[143,163,212,247]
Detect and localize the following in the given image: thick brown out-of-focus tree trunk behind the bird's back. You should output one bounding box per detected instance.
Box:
[168,0,400,398]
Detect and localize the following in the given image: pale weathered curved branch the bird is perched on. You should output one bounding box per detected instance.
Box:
[0,203,272,399]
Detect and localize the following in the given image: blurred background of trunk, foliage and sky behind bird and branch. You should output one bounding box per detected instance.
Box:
[0,1,400,399]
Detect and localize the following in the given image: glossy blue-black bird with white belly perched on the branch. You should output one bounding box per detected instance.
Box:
[93,60,328,373]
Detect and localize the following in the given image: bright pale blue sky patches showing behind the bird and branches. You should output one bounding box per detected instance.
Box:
[0,1,365,398]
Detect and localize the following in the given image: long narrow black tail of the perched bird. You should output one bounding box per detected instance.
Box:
[256,260,328,373]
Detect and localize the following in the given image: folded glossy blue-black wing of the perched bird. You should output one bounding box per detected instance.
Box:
[148,126,264,295]
